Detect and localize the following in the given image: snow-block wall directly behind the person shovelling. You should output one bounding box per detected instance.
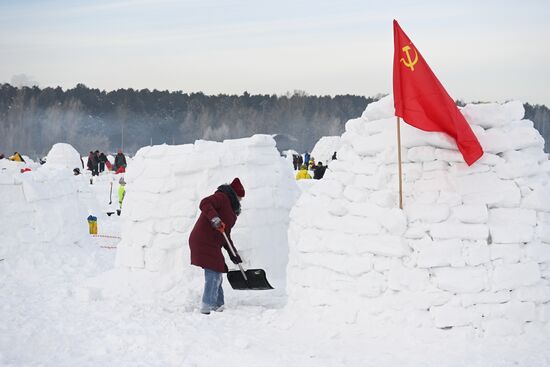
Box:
[93,135,298,300]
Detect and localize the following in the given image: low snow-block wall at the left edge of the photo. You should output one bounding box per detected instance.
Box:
[0,156,88,259]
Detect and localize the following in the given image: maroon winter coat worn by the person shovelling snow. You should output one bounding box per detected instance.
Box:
[189,191,237,273]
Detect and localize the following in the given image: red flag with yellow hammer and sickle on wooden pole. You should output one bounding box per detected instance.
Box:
[393,20,483,165]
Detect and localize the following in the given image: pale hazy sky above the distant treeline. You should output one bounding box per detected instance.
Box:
[0,0,550,106]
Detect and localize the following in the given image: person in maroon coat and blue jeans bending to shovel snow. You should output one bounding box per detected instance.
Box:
[189,178,244,315]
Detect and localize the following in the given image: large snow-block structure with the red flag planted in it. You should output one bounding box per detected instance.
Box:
[288,97,550,335]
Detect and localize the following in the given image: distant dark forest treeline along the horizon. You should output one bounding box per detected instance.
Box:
[0,84,550,158]
